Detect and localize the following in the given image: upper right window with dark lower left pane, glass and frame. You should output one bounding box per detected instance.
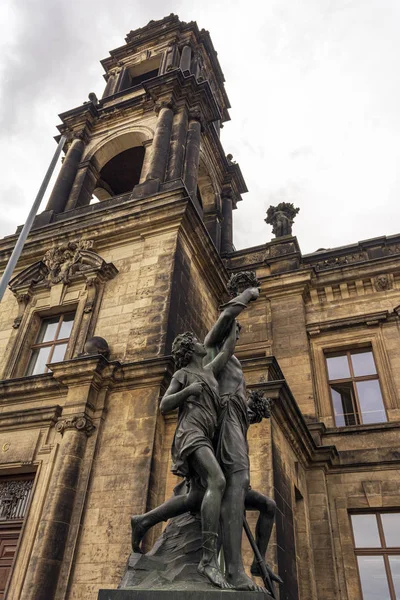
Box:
[326,348,387,427]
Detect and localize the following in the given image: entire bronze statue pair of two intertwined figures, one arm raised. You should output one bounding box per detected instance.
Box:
[131,274,279,591]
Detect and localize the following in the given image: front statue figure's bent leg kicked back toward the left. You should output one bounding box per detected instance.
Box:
[131,490,203,552]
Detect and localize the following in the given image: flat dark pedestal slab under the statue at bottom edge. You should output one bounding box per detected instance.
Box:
[98,588,270,600]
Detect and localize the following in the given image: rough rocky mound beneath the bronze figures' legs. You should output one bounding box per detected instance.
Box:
[119,513,216,592]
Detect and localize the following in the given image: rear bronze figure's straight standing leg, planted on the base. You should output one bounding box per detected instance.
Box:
[221,469,264,591]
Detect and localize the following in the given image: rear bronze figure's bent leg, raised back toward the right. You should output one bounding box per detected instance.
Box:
[245,490,278,581]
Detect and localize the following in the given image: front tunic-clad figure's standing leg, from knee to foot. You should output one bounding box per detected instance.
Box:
[189,446,230,589]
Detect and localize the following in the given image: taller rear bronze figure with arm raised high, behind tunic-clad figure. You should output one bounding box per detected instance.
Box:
[204,287,281,591]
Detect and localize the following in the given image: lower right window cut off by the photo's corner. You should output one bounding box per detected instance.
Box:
[351,512,400,600]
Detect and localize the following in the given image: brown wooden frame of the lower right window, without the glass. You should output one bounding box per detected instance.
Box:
[349,509,400,600]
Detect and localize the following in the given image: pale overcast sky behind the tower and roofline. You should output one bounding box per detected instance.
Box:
[0,0,400,253]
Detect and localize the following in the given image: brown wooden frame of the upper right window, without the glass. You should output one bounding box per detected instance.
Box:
[323,344,389,428]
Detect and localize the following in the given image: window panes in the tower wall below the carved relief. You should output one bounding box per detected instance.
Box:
[25,313,75,375]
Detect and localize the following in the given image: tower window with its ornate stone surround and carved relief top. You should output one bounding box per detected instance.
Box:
[3,239,118,378]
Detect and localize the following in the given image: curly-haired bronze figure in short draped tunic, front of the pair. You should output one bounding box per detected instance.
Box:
[131,323,235,589]
